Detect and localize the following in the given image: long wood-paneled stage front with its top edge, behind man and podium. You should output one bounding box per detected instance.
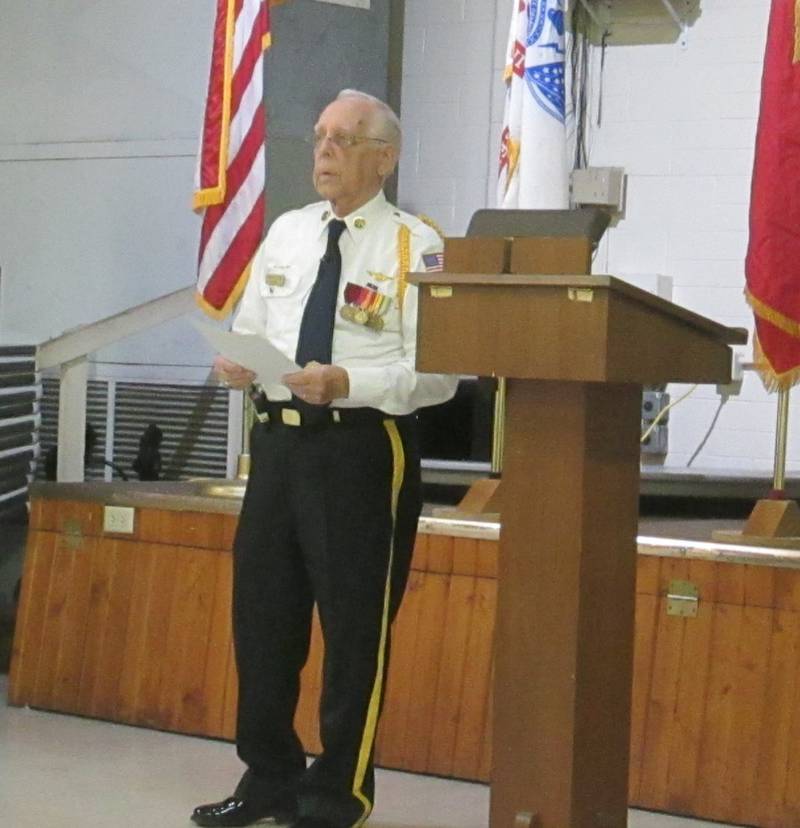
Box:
[9,484,800,828]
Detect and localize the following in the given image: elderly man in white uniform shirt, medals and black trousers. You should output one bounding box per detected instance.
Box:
[192,90,456,828]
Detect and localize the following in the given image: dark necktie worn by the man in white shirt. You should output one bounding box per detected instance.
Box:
[295,219,347,368]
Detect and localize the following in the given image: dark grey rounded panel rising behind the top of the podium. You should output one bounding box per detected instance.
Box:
[467,207,611,244]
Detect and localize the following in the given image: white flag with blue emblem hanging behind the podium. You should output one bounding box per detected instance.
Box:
[497,0,569,210]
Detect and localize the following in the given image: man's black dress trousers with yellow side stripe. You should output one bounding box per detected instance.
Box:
[234,411,421,828]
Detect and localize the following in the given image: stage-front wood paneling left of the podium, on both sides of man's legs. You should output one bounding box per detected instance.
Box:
[9,500,497,779]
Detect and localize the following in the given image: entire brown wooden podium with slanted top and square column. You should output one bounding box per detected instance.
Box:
[409,273,747,828]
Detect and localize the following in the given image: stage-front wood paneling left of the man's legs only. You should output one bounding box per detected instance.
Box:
[9,501,236,736]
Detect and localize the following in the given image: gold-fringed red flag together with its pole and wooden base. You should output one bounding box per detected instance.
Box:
[712,0,800,549]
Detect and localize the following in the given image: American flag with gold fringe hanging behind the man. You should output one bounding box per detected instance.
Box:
[194,0,270,318]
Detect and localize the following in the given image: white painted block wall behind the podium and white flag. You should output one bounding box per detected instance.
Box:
[400,0,800,471]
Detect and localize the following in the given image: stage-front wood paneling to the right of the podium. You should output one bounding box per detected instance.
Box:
[630,556,800,828]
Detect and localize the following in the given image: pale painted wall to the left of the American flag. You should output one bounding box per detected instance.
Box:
[0,0,214,365]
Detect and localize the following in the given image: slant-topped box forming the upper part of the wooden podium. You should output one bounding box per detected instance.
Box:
[408,273,748,384]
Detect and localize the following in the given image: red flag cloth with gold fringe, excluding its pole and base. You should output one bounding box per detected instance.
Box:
[745,0,800,390]
